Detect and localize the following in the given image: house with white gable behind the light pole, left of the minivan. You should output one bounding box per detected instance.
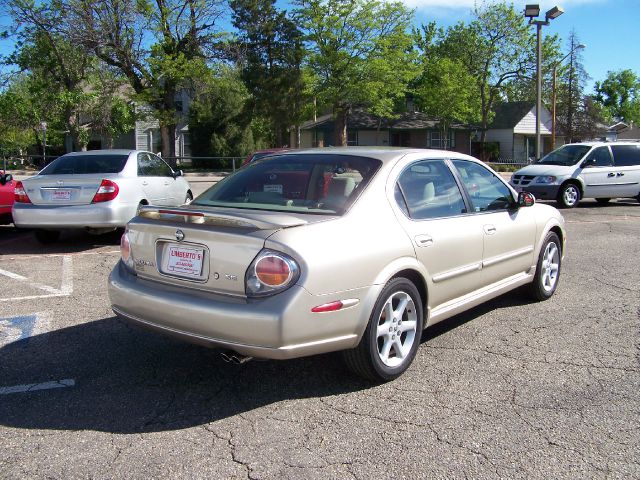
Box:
[485,102,562,163]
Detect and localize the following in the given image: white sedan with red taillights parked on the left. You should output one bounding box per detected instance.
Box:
[13,150,193,243]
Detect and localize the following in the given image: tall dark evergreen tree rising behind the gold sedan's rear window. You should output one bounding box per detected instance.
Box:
[231,0,304,146]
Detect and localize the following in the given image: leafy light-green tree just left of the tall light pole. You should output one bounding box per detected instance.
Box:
[441,3,535,142]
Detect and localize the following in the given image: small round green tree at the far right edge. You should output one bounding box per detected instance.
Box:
[595,69,640,124]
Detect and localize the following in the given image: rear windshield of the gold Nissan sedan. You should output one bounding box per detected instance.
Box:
[192,154,381,215]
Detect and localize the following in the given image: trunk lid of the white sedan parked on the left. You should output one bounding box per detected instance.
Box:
[22,174,112,205]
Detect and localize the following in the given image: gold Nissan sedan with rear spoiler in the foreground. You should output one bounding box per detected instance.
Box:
[109,148,566,381]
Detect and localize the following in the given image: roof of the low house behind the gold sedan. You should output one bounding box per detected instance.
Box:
[300,109,469,130]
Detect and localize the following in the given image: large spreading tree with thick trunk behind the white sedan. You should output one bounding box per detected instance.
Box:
[63,0,223,163]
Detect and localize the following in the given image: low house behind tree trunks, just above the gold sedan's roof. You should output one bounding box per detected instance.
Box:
[291,109,477,153]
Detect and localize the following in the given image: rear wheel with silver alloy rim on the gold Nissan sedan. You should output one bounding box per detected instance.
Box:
[343,278,424,382]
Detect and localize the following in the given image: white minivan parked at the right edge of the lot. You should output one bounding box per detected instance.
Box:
[511,142,640,208]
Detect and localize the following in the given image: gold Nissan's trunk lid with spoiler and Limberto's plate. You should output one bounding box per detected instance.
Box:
[128,203,327,296]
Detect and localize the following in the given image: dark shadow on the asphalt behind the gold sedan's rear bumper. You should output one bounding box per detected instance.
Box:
[0,317,373,433]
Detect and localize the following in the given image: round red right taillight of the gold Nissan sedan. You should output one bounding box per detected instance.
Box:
[245,250,300,297]
